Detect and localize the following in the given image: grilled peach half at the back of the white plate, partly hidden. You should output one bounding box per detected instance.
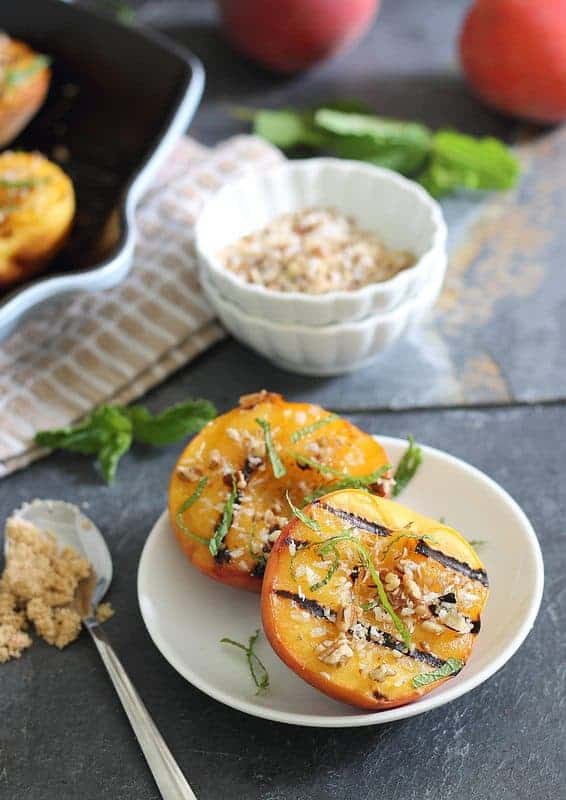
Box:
[169,391,391,592]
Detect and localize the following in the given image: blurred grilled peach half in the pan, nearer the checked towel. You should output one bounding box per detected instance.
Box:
[0,150,75,290]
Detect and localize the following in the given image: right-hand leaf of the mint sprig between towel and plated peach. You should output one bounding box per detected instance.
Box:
[126,400,216,446]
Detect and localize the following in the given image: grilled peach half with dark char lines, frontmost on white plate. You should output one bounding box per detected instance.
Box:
[262,490,488,711]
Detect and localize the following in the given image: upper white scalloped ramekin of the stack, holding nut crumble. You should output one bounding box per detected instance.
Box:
[195,158,446,326]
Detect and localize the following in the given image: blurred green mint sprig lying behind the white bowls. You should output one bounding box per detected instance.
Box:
[239,101,520,197]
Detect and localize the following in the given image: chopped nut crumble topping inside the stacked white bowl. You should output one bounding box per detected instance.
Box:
[220,208,415,294]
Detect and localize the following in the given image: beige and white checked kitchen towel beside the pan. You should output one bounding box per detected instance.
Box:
[0,136,282,477]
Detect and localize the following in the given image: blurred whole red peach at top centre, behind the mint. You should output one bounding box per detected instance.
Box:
[217,0,379,72]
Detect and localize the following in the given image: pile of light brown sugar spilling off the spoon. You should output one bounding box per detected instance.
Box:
[0,517,114,664]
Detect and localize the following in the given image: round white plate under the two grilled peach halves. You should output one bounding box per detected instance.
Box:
[138,436,543,728]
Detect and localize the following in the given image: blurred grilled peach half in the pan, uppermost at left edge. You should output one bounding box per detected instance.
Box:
[0,34,51,147]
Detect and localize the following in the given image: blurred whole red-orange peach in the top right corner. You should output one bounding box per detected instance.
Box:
[460,0,566,123]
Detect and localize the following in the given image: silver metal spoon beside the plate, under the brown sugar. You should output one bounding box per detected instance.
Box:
[11,500,197,800]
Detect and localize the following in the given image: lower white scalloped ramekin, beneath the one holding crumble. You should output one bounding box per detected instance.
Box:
[201,253,446,375]
